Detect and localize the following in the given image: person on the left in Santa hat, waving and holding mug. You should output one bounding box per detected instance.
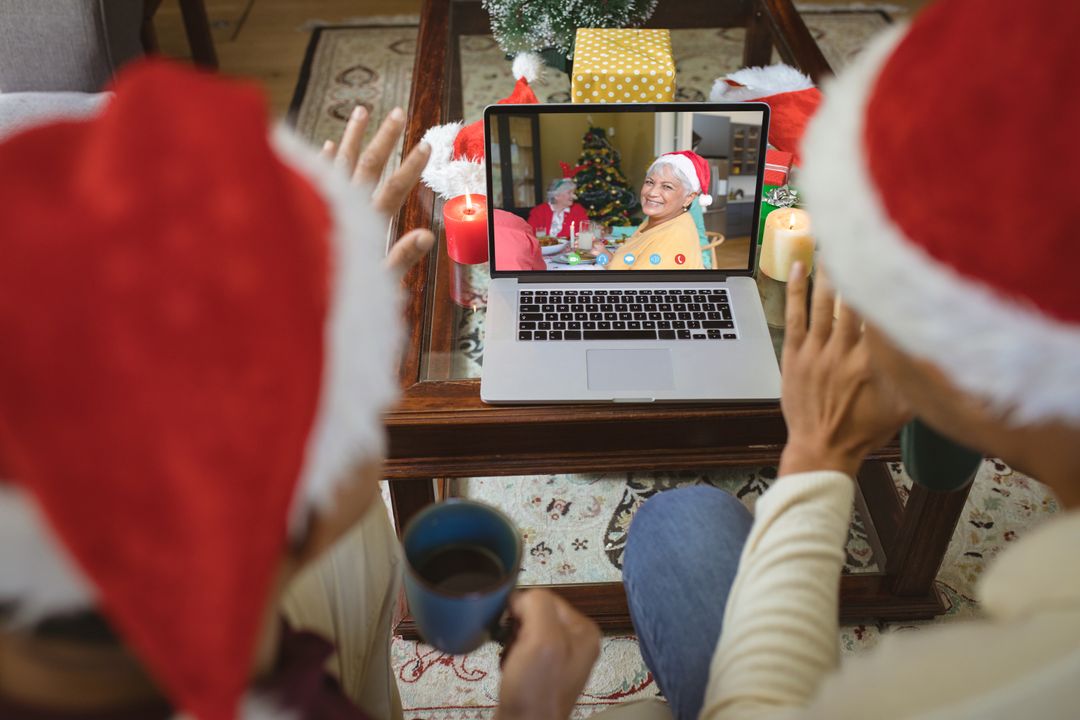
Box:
[0,62,598,720]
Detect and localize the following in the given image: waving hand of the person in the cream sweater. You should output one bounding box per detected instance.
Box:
[780,263,910,477]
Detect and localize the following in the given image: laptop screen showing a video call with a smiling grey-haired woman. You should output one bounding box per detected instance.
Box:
[484,103,769,276]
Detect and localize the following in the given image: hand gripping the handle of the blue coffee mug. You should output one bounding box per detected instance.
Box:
[496,589,600,720]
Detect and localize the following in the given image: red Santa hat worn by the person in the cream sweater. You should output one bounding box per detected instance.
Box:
[802,0,1080,424]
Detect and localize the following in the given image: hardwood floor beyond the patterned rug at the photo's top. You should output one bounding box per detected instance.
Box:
[154,0,926,116]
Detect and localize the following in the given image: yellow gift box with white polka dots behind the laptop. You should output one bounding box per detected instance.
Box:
[570,28,675,103]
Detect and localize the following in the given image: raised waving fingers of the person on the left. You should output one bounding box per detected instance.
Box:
[321,106,435,276]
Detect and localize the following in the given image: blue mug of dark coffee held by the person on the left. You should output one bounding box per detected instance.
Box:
[402,498,522,655]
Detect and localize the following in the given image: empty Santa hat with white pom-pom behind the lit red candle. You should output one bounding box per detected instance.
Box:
[420,53,543,200]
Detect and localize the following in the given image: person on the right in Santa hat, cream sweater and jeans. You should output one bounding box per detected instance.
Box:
[623,0,1080,720]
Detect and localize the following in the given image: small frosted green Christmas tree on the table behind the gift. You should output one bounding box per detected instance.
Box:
[483,0,657,57]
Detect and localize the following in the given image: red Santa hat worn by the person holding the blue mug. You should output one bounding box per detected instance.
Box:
[0,62,400,720]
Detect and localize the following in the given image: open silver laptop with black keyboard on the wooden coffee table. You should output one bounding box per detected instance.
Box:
[481,103,780,403]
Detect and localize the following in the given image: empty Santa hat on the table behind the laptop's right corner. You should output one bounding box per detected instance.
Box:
[708,64,821,164]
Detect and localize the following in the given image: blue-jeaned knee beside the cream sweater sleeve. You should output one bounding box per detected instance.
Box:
[622,486,753,720]
